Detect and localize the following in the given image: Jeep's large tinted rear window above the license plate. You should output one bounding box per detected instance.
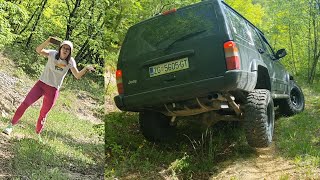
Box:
[121,3,218,60]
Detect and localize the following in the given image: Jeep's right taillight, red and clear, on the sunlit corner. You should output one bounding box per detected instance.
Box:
[223,41,240,70]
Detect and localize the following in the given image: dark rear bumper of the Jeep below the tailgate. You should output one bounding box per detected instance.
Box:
[114,71,257,111]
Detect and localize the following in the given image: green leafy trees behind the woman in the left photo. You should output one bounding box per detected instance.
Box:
[0,0,103,77]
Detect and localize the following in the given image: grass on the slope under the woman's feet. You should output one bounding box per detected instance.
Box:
[4,104,104,179]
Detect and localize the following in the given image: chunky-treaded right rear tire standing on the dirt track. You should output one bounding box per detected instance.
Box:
[244,89,275,148]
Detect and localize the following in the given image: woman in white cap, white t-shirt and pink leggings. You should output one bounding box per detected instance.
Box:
[3,37,94,140]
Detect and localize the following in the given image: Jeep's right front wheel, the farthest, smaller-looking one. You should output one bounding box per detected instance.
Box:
[279,80,305,116]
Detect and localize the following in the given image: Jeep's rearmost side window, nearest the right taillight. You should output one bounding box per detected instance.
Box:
[225,7,252,43]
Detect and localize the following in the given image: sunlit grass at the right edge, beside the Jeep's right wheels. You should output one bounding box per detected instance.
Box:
[276,81,320,167]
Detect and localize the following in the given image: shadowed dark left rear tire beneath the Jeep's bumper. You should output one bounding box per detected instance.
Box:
[139,111,175,142]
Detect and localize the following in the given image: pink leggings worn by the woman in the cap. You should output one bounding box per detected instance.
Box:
[11,81,59,134]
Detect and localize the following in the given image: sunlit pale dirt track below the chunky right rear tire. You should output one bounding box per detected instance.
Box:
[210,145,320,180]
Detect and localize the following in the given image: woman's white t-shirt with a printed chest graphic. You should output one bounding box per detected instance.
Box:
[40,50,76,90]
